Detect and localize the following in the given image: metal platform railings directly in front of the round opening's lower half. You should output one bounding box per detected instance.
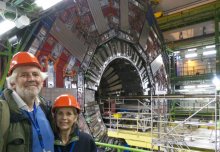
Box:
[101,99,153,131]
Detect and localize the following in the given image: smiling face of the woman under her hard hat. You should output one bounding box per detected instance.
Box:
[55,108,78,131]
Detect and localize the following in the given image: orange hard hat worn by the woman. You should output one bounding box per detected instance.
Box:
[52,94,80,113]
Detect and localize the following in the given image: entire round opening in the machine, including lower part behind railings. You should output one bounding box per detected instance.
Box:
[95,58,148,130]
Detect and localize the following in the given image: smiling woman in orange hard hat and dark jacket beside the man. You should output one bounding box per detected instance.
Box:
[52,94,97,152]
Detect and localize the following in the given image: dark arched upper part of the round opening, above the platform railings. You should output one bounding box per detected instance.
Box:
[96,58,143,97]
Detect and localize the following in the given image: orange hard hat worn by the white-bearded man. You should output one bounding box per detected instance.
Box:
[8,52,41,75]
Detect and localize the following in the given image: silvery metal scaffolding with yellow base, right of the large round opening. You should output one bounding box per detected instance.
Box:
[100,92,220,152]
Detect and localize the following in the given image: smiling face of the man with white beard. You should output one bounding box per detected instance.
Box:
[13,66,43,98]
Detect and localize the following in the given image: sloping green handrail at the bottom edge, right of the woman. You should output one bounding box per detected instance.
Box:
[96,142,150,152]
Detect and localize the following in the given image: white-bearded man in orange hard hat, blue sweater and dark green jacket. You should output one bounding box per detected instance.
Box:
[0,52,54,152]
